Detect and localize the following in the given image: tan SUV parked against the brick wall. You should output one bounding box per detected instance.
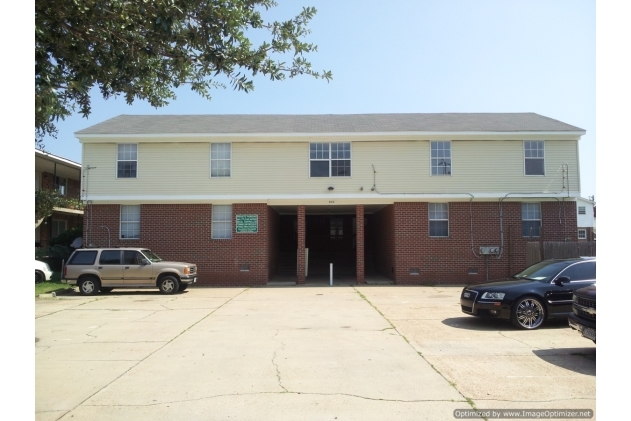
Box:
[61,247,197,295]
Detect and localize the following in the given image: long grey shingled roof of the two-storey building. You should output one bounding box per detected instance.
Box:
[75,113,584,136]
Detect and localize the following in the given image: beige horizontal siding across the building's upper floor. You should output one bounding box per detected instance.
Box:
[83,140,578,197]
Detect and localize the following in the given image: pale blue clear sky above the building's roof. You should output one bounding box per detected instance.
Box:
[35,0,596,198]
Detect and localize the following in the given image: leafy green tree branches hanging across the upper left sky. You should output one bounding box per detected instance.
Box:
[35,0,332,142]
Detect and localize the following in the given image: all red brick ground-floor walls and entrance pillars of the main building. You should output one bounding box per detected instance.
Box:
[84,201,577,286]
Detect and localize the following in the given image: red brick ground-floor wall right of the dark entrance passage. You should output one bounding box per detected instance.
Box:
[371,201,577,284]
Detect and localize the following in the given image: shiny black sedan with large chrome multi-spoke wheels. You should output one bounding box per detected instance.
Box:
[460,257,596,329]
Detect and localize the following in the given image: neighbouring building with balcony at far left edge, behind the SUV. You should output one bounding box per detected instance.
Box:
[35,149,83,247]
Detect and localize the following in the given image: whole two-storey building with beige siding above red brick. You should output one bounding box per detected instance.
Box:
[76,113,585,285]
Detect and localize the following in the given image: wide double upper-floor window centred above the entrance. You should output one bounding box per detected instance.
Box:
[309,143,351,177]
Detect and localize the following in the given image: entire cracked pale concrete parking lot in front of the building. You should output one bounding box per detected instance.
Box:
[35,286,596,421]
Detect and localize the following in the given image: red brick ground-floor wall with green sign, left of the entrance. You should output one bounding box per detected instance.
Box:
[84,203,277,286]
